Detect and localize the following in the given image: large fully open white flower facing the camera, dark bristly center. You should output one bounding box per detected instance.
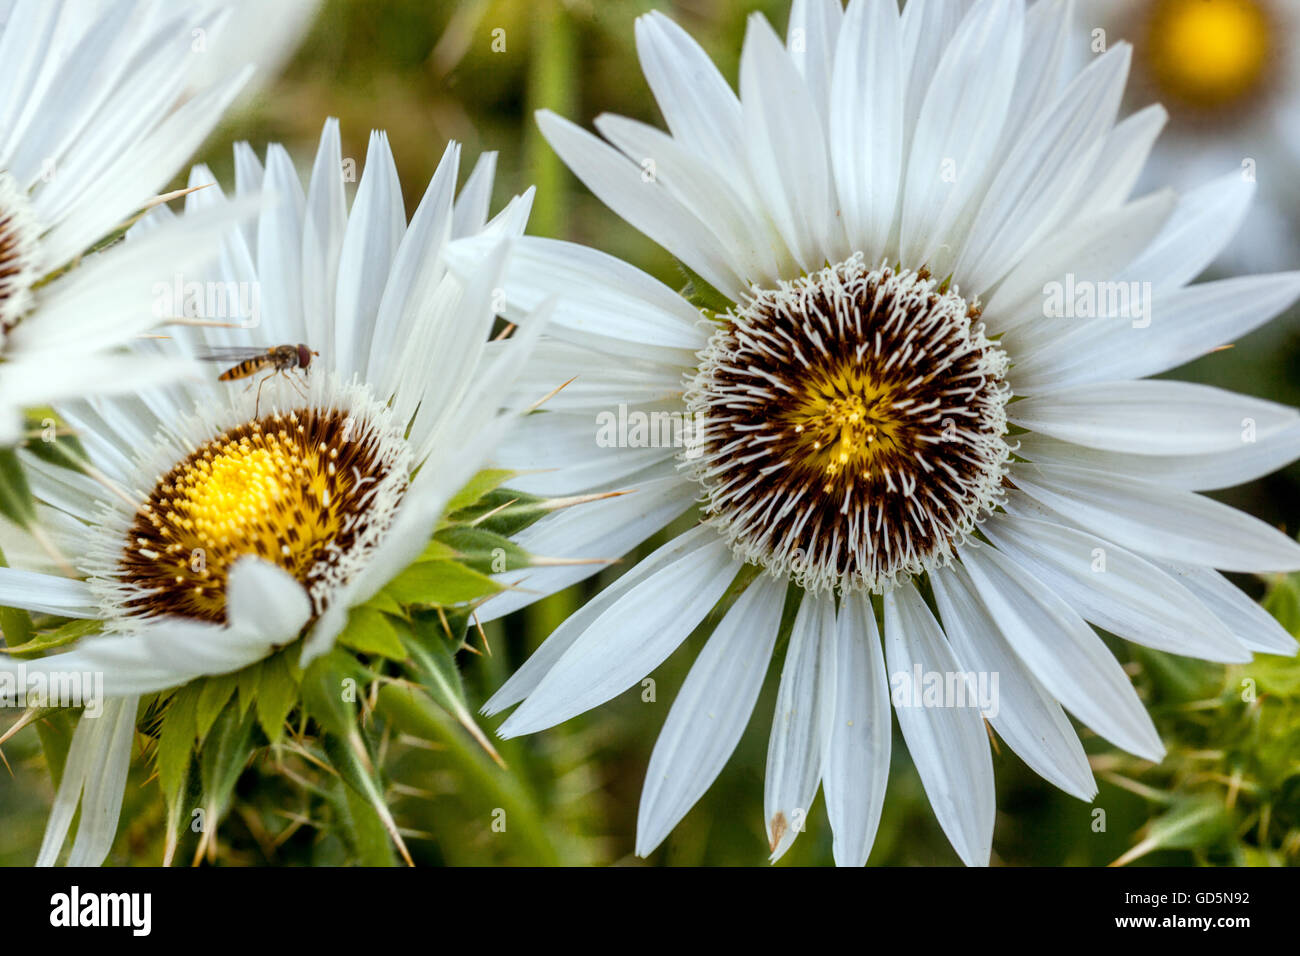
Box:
[452,0,1300,864]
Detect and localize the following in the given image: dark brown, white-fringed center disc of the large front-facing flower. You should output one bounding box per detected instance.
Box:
[684,256,1010,592]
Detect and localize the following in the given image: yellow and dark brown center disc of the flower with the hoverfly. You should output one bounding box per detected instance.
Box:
[121,410,406,622]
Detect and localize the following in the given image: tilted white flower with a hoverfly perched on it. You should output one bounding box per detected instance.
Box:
[0,121,541,865]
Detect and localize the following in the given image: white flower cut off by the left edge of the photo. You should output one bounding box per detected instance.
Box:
[0,0,261,445]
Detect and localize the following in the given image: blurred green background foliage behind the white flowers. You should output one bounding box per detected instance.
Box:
[0,0,1300,865]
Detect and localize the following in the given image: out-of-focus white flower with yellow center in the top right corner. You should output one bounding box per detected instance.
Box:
[1080,0,1300,269]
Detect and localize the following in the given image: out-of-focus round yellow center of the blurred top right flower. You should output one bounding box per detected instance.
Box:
[1148,0,1273,109]
